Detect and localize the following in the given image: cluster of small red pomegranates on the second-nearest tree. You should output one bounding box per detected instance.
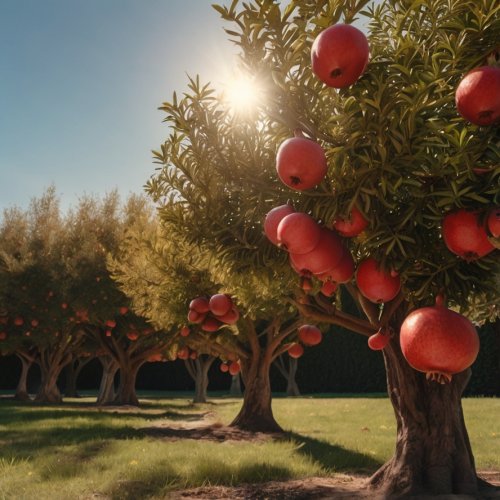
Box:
[188,293,240,336]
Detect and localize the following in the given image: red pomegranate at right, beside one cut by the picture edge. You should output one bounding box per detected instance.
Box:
[442,208,494,260]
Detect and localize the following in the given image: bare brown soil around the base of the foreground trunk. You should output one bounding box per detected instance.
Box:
[168,471,500,500]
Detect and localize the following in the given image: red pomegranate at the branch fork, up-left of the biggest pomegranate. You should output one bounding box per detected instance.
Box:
[356,257,401,303]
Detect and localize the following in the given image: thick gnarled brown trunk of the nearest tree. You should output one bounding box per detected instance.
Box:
[370,320,492,498]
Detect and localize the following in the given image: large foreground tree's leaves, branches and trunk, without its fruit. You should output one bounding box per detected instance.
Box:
[148,0,500,495]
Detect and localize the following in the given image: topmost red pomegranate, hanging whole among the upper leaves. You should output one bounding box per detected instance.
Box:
[311,23,370,89]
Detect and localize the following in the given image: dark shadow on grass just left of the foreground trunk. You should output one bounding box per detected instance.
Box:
[286,432,383,474]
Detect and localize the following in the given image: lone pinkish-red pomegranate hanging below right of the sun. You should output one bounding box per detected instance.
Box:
[276,132,328,191]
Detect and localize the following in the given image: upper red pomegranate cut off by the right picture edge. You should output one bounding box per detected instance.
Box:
[455,66,500,126]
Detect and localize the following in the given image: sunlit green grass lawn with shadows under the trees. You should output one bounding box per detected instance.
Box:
[0,396,500,500]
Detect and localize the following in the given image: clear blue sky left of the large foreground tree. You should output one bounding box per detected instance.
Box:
[0,0,236,210]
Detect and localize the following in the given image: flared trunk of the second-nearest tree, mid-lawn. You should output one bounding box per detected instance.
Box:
[230,354,283,432]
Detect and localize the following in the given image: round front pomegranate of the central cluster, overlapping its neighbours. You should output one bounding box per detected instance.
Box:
[278,212,321,254]
